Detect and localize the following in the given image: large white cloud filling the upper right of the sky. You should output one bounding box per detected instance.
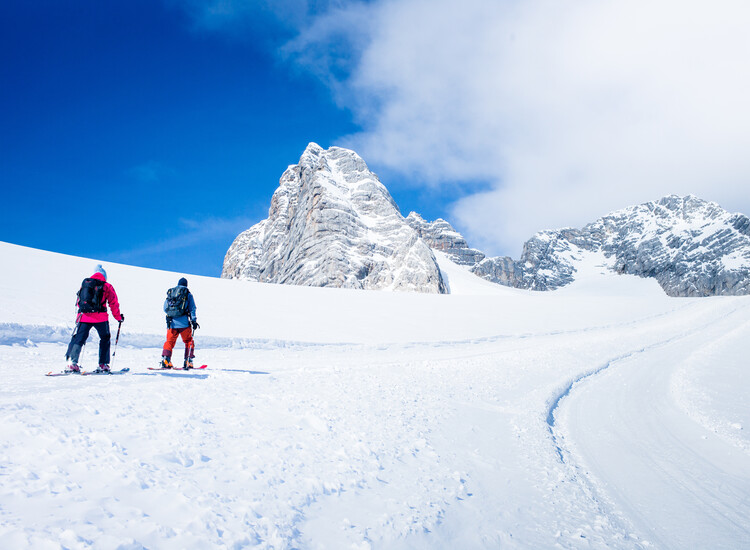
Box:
[181,0,750,255]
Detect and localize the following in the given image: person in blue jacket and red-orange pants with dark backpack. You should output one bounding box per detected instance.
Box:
[161,277,200,369]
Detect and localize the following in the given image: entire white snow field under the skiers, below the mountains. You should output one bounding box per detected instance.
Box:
[0,243,750,549]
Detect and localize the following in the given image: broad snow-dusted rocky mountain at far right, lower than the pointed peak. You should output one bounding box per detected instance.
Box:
[472,195,750,296]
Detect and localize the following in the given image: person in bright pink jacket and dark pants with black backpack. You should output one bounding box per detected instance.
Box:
[65,264,125,372]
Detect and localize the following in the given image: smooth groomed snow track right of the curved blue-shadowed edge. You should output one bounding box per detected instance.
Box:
[547,303,750,549]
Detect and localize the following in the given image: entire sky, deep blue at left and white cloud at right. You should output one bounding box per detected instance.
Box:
[0,0,750,275]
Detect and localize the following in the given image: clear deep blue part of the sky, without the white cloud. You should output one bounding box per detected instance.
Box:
[0,0,458,275]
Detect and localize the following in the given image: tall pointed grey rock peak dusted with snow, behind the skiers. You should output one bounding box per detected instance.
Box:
[222,143,446,293]
